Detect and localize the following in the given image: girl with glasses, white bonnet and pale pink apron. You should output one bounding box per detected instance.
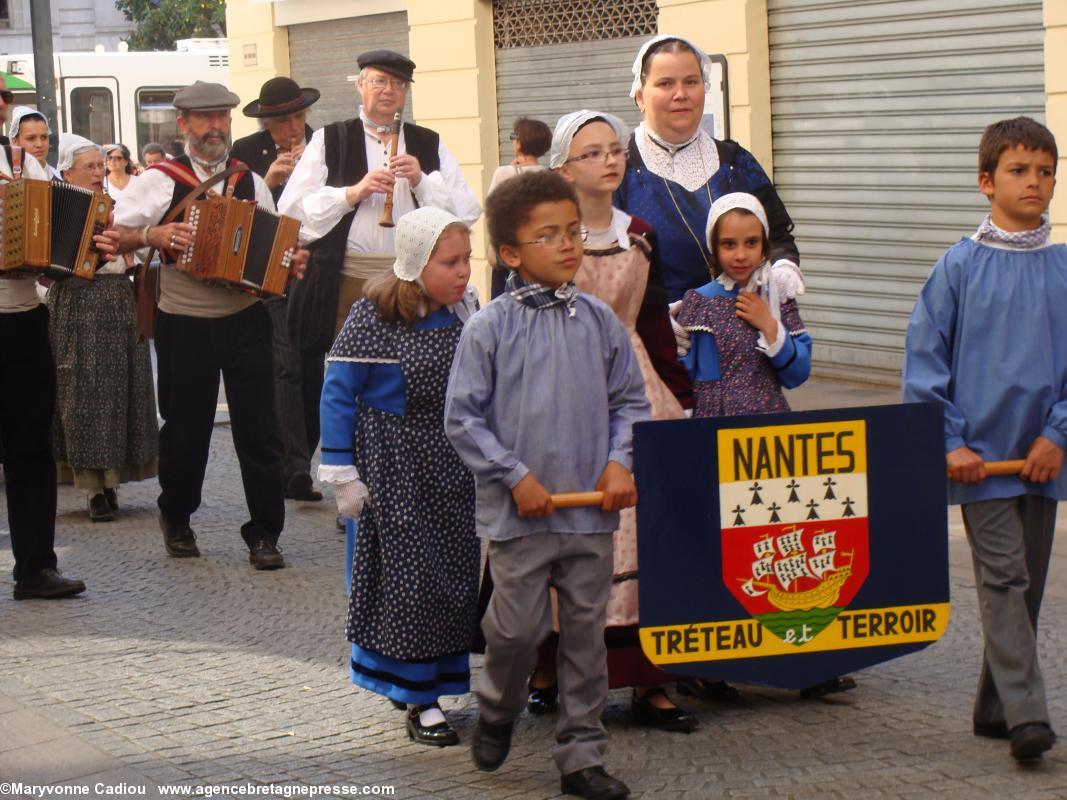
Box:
[527,109,697,733]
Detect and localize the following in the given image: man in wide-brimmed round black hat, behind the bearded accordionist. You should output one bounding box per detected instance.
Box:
[229,77,322,501]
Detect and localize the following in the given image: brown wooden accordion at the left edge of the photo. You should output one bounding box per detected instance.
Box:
[0,178,112,279]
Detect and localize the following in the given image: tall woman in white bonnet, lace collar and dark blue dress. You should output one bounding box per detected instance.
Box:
[616,35,803,346]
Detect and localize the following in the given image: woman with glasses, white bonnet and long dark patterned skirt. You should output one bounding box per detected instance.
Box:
[48,133,159,523]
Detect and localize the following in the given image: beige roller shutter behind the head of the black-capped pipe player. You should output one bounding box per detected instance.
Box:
[289,12,418,129]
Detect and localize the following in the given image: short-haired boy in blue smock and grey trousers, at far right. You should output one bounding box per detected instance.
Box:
[904,117,1067,762]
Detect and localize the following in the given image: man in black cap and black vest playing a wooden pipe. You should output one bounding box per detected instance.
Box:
[278,50,481,460]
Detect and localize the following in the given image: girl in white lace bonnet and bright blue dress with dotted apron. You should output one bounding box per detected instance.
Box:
[318,207,480,747]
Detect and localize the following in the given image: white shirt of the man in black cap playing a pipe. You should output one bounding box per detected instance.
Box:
[277,127,481,256]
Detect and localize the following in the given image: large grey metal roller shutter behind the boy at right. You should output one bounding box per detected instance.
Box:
[767,0,1045,383]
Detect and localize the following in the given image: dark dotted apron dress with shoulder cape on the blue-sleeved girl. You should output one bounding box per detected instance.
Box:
[334,301,479,661]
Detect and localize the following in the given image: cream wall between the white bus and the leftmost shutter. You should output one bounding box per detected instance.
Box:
[226,0,289,139]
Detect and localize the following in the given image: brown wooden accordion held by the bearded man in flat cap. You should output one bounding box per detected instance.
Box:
[176,195,300,297]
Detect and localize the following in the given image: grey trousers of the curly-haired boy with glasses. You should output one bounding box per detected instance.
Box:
[475,533,612,774]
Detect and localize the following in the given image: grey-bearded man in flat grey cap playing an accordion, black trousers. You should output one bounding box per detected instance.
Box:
[115,81,306,570]
